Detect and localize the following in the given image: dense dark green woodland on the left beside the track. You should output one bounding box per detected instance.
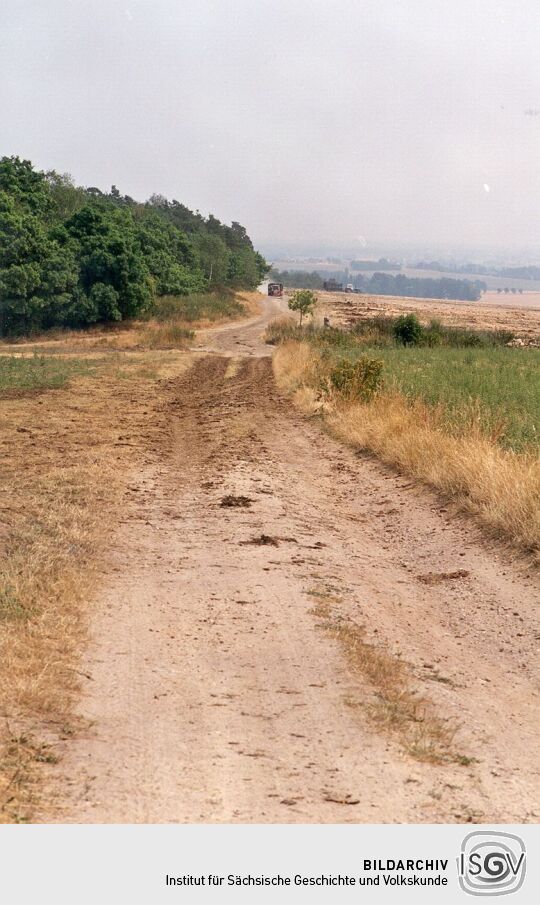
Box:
[0,157,268,335]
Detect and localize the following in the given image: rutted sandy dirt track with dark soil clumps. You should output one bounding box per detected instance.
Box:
[48,301,540,823]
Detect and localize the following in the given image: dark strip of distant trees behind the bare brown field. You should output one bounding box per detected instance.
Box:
[271,270,487,301]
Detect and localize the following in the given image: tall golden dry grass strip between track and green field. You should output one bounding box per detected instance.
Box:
[274,343,540,557]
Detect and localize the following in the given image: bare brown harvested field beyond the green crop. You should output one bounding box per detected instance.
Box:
[317,292,540,342]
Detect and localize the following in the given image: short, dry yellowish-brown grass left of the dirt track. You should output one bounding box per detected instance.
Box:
[0,346,191,822]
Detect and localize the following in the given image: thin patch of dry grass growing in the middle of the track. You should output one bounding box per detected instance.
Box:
[308,589,460,764]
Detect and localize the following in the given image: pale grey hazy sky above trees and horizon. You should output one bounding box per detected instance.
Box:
[0,0,540,250]
